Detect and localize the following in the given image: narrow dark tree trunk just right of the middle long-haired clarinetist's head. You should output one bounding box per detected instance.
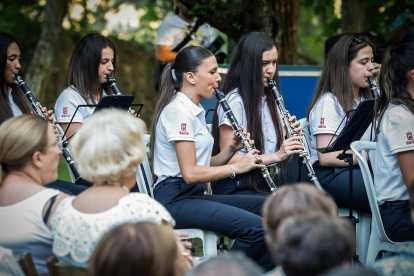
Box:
[273,0,300,65]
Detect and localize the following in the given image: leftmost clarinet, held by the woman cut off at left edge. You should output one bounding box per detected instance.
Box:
[15,74,84,184]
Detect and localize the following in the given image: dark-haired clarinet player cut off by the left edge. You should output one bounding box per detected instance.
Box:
[0,32,87,194]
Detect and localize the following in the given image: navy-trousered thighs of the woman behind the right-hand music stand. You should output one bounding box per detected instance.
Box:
[313,162,371,214]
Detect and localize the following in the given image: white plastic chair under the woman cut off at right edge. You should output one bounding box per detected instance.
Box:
[351,141,413,266]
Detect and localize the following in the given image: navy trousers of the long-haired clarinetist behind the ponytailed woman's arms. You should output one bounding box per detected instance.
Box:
[217,176,269,197]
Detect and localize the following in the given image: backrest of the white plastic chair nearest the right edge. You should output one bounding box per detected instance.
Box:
[351,141,392,242]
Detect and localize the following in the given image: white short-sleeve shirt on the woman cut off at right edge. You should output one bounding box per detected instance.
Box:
[374,104,414,205]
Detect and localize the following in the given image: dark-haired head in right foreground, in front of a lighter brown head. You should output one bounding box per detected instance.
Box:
[273,212,355,276]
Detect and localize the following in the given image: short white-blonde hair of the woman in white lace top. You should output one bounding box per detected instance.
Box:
[70,108,146,182]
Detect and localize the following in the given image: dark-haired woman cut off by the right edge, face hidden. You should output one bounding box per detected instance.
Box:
[374,42,414,242]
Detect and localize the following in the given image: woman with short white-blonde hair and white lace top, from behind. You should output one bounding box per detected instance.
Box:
[51,109,175,268]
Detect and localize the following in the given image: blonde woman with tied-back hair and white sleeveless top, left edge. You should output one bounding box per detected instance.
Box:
[0,115,67,275]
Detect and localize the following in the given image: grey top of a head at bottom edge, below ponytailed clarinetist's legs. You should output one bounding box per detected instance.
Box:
[186,252,263,276]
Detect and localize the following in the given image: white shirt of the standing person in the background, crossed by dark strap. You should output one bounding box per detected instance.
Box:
[156,15,211,49]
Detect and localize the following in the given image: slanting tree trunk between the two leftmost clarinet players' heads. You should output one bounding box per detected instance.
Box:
[25,0,67,102]
